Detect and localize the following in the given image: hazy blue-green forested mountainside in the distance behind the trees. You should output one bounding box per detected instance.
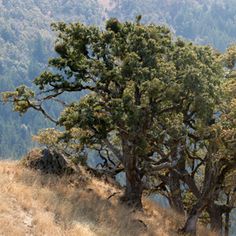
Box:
[0,0,236,158]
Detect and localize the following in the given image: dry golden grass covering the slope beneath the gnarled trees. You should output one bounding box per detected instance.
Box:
[0,161,215,236]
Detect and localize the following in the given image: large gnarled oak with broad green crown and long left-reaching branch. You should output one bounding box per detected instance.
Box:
[4,17,222,208]
